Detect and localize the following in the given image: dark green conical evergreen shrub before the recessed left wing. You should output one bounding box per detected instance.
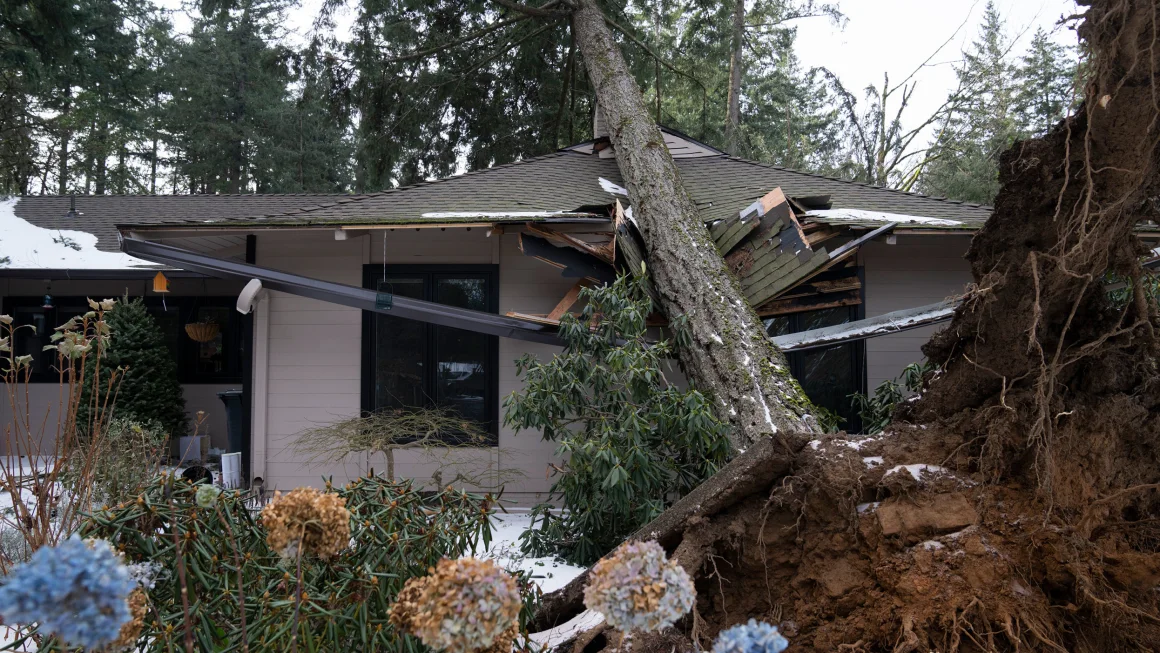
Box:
[78,298,187,437]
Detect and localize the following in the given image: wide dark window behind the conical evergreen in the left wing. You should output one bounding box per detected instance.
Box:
[0,296,242,384]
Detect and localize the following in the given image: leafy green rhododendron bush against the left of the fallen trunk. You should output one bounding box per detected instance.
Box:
[505,275,730,565]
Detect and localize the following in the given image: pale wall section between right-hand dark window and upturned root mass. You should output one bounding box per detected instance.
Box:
[860,234,971,391]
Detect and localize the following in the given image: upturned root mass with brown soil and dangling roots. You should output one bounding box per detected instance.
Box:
[535,0,1160,653]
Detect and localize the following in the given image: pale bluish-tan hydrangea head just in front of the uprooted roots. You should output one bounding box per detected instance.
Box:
[583,542,697,632]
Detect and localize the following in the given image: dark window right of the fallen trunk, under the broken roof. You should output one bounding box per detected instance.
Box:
[764,306,865,433]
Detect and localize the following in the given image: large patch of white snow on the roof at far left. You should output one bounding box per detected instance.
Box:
[0,198,158,270]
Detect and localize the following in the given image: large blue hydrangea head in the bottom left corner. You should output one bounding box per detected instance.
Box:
[0,535,135,650]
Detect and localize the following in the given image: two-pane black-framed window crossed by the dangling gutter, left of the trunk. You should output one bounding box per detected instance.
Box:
[363,264,499,443]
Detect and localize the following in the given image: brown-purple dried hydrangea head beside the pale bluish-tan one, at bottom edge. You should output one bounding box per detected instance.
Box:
[391,558,521,653]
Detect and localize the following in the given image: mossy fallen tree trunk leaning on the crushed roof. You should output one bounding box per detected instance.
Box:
[572,0,818,449]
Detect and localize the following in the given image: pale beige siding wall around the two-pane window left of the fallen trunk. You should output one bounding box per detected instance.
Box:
[253,227,575,503]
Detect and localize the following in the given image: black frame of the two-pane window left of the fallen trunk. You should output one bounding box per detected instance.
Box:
[361,263,500,447]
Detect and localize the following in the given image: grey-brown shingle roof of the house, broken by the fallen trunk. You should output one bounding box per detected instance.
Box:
[9,151,991,251]
